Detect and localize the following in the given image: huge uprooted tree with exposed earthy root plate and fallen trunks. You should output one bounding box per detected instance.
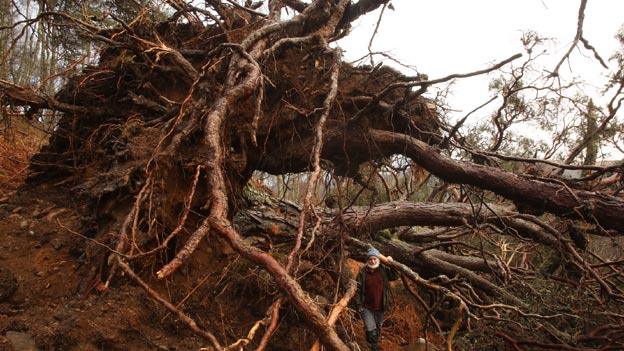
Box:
[0,0,624,350]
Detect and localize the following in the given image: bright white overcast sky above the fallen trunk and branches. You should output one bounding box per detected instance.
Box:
[339,0,624,159]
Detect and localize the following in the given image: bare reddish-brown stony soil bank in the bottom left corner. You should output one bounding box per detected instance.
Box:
[0,190,200,350]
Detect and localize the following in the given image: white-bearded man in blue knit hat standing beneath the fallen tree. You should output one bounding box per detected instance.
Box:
[355,248,399,351]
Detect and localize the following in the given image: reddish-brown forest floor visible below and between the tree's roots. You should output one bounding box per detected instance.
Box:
[0,123,440,351]
